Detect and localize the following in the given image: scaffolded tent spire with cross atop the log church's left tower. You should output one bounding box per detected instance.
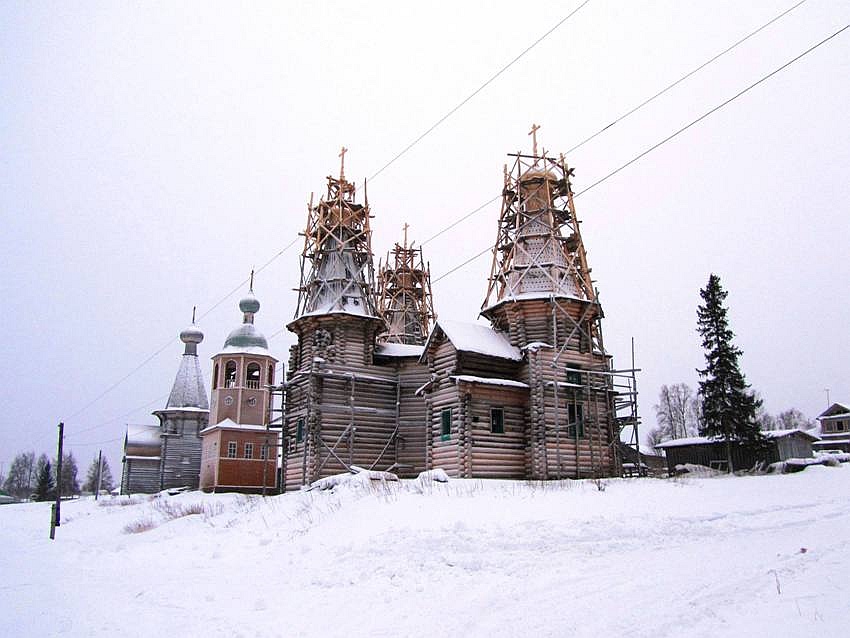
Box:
[295,148,377,318]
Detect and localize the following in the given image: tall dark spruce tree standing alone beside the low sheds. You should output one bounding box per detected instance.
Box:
[697,273,764,472]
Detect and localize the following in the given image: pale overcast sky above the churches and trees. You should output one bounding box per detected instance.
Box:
[0,0,850,477]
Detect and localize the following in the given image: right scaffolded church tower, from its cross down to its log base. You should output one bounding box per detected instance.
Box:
[482,125,639,478]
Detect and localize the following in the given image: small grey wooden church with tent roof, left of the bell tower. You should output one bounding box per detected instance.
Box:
[121,324,209,494]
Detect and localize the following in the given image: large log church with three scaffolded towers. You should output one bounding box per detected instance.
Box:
[281,136,637,489]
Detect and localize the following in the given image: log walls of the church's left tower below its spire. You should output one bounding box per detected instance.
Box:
[284,313,428,489]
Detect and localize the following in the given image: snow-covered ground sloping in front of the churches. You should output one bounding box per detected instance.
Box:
[0,464,850,638]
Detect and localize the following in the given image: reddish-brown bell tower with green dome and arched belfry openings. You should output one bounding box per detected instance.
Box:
[200,290,278,493]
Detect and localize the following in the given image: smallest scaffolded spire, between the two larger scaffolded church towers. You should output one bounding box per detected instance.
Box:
[378,224,436,345]
